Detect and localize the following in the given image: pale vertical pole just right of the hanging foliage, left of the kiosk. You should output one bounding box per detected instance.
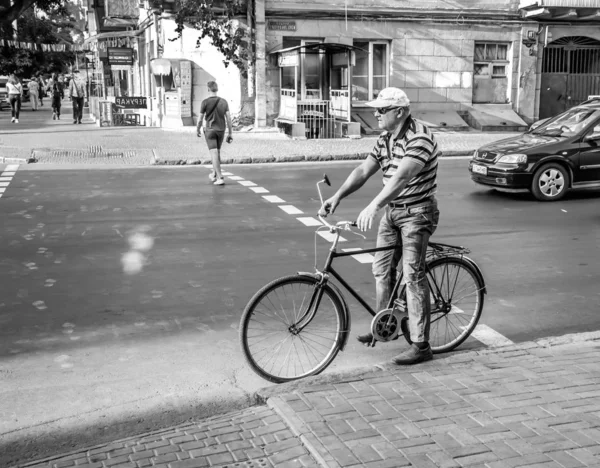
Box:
[254,0,267,128]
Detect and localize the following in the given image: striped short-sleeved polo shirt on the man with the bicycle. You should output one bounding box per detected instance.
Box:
[369,117,441,204]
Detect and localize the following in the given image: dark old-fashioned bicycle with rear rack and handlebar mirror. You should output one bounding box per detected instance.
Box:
[240,175,487,383]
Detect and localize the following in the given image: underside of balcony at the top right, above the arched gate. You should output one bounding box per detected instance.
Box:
[519,0,600,23]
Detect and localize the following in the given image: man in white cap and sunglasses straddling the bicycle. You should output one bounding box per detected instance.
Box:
[319,88,441,365]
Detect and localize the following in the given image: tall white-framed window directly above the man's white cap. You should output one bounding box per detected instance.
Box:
[352,41,389,101]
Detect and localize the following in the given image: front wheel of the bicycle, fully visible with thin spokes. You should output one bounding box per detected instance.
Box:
[240,275,345,383]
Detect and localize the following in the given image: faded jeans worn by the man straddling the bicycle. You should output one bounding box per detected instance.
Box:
[373,198,440,342]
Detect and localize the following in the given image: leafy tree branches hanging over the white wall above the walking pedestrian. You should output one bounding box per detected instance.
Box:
[171,0,249,77]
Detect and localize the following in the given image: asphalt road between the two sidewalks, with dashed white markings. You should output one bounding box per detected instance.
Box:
[0,160,600,466]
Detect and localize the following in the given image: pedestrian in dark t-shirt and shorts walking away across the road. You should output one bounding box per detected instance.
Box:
[196,81,233,185]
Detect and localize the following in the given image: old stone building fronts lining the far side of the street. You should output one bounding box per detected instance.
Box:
[83,0,600,133]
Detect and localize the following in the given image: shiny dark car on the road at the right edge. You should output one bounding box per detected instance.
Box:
[469,102,600,201]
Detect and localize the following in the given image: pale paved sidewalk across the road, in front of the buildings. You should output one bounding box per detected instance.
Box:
[0,100,517,165]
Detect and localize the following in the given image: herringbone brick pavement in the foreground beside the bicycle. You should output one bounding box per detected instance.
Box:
[16,333,600,468]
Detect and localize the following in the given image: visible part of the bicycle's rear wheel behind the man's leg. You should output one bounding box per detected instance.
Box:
[427,257,484,353]
